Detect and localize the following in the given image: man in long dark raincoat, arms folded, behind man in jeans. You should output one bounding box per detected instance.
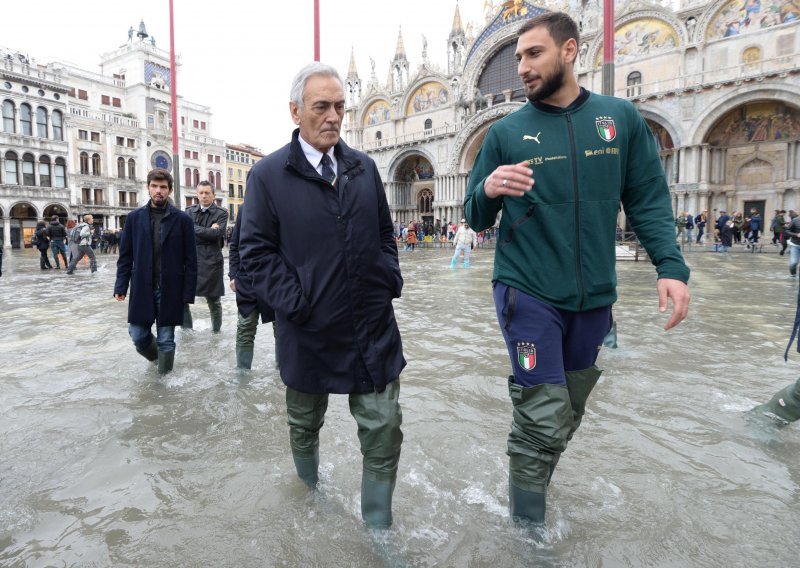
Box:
[182,181,228,333]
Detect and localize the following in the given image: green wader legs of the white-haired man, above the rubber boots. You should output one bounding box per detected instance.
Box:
[286,379,403,483]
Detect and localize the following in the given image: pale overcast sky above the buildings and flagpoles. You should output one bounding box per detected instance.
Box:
[0,0,484,153]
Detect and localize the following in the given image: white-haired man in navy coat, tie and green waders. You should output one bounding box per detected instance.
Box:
[239,63,405,528]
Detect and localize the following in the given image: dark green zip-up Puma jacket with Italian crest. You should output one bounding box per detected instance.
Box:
[464,90,689,311]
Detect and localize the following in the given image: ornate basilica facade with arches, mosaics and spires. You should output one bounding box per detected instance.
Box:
[344,0,800,228]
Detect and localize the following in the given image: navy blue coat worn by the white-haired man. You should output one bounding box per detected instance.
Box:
[239,130,406,394]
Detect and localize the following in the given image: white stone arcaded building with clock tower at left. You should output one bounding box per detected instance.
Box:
[0,24,226,248]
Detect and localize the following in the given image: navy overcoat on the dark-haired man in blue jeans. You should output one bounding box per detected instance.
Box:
[114,204,197,326]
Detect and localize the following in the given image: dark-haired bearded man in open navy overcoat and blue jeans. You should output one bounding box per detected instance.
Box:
[114,168,197,374]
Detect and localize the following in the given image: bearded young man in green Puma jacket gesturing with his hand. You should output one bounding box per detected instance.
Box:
[464,13,689,524]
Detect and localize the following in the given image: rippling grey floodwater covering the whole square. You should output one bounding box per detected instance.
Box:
[0,247,800,568]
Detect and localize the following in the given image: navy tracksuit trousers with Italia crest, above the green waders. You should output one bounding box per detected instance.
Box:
[494,282,611,387]
